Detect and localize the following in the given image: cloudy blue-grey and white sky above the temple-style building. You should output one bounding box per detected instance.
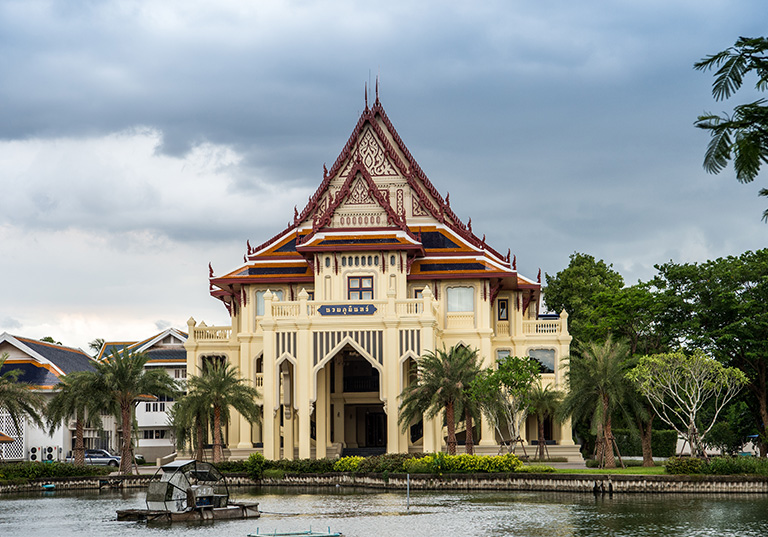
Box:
[0,0,768,348]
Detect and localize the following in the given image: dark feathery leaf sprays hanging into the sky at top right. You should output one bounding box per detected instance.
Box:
[694,37,768,221]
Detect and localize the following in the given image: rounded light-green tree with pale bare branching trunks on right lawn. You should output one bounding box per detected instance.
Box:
[627,350,747,455]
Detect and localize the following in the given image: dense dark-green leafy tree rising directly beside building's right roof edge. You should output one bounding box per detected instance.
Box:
[544,253,624,343]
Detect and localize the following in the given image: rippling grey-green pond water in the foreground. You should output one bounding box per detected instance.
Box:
[0,488,768,537]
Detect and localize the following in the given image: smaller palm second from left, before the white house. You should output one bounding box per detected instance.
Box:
[45,371,103,466]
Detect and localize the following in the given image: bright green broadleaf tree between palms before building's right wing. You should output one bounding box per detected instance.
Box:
[471,356,539,452]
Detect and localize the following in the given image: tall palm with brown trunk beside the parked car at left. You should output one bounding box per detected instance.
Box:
[96,347,177,474]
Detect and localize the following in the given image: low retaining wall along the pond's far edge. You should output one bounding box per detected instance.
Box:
[0,473,768,494]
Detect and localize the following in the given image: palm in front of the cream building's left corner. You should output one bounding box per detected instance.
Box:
[187,360,261,463]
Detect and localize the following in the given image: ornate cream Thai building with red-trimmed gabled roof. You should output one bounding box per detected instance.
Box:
[185,91,580,459]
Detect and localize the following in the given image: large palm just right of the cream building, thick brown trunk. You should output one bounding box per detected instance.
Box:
[558,338,634,468]
